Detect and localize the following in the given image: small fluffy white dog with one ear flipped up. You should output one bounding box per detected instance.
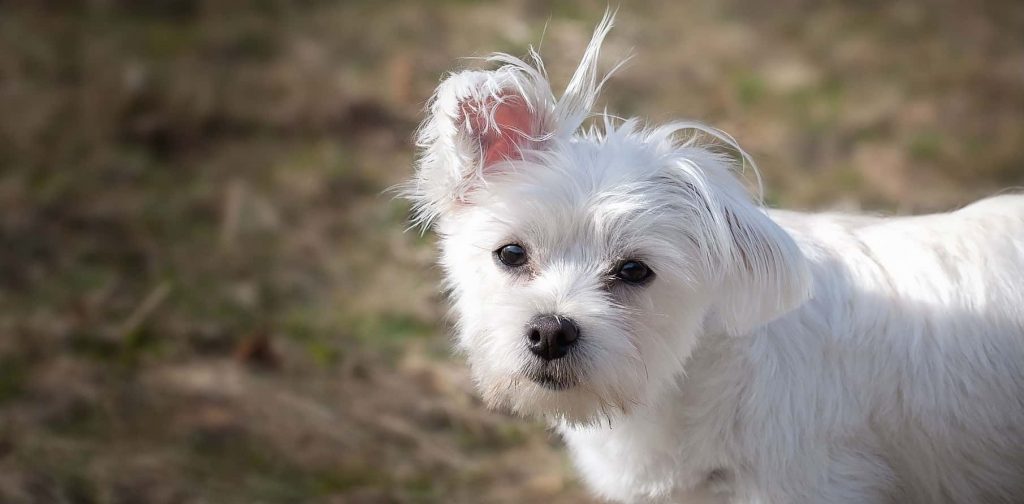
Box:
[407,12,1024,504]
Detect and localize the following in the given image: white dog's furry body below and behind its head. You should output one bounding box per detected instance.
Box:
[560,196,1024,504]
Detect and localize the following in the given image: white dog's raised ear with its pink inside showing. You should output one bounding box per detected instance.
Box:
[407,66,554,223]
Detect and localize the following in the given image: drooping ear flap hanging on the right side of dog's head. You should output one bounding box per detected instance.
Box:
[715,201,811,335]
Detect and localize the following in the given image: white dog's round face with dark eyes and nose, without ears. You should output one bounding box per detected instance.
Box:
[438,140,724,420]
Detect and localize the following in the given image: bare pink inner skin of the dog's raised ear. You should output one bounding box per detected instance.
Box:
[463,94,537,167]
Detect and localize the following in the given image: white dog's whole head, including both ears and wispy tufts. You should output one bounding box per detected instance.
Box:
[408,16,809,422]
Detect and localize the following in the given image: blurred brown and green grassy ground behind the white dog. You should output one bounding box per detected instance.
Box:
[0,0,1024,503]
